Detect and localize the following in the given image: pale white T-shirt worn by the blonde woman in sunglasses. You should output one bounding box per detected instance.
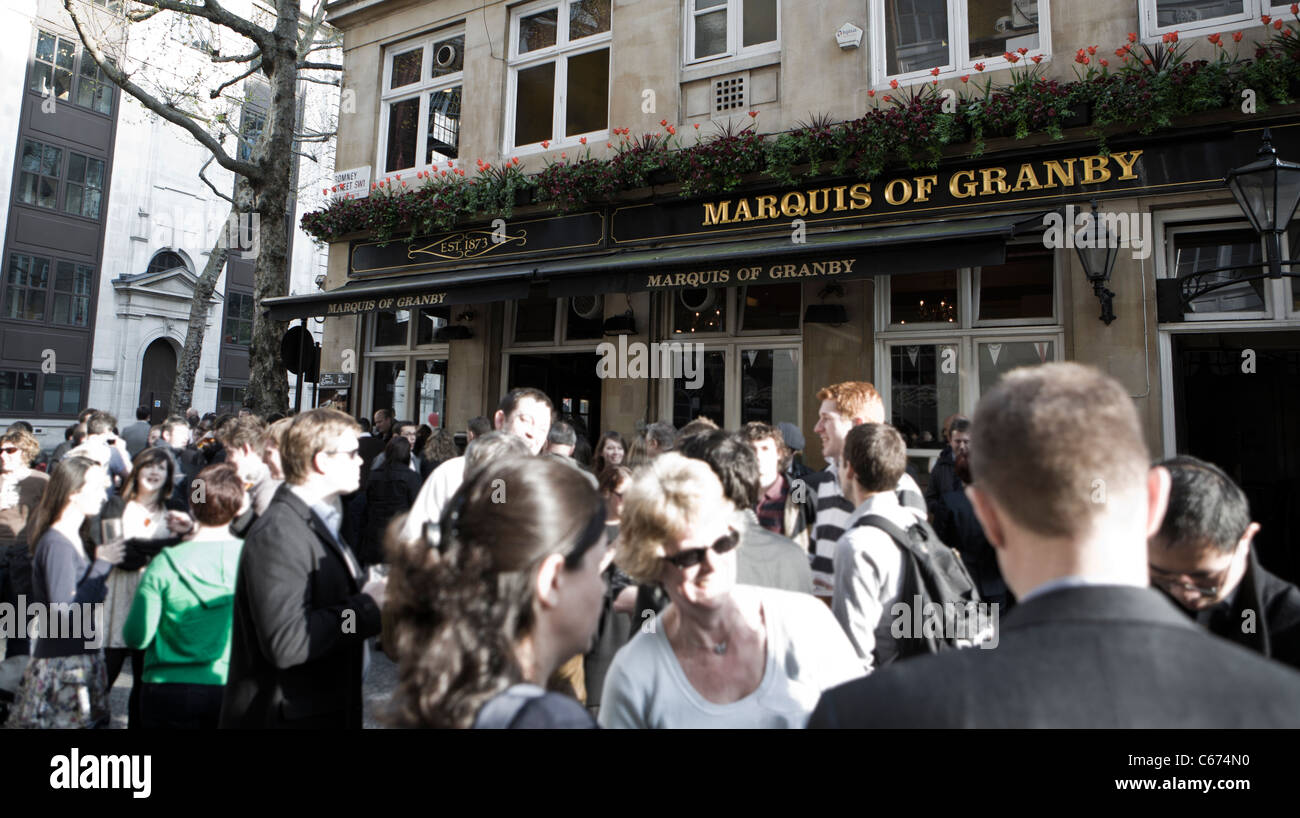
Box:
[599,585,862,730]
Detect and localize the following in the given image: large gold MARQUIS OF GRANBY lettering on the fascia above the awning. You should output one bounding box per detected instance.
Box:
[696,150,1143,224]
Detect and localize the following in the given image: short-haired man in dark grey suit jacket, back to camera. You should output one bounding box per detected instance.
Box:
[809,364,1300,727]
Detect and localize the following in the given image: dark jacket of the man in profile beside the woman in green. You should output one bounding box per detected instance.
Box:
[221,485,380,728]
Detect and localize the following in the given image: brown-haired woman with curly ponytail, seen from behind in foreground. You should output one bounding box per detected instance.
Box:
[385,455,608,728]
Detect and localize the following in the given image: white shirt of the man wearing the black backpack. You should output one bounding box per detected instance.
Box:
[831,492,917,674]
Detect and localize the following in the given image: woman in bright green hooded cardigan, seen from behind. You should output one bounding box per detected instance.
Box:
[122,463,247,730]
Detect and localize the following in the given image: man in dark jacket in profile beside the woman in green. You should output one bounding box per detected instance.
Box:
[221,408,386,728]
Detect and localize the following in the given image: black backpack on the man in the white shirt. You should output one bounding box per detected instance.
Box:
[854,514,997,659]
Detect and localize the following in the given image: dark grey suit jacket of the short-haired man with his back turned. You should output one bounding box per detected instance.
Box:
[809,585,1300,728]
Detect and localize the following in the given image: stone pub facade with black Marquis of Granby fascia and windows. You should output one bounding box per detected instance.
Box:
[282,0,1300,577]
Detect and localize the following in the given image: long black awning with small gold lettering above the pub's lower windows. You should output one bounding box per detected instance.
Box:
[263,211,1045,321]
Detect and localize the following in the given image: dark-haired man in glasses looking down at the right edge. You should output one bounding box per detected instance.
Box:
[1147,456,1300,667]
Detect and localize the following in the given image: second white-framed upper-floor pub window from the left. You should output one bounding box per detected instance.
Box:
[506,0,611,152]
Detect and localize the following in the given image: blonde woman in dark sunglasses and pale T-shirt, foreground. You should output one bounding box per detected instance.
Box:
[599,453,862,728]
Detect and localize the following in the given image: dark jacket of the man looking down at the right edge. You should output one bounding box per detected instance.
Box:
[1179,550,1300,668]
